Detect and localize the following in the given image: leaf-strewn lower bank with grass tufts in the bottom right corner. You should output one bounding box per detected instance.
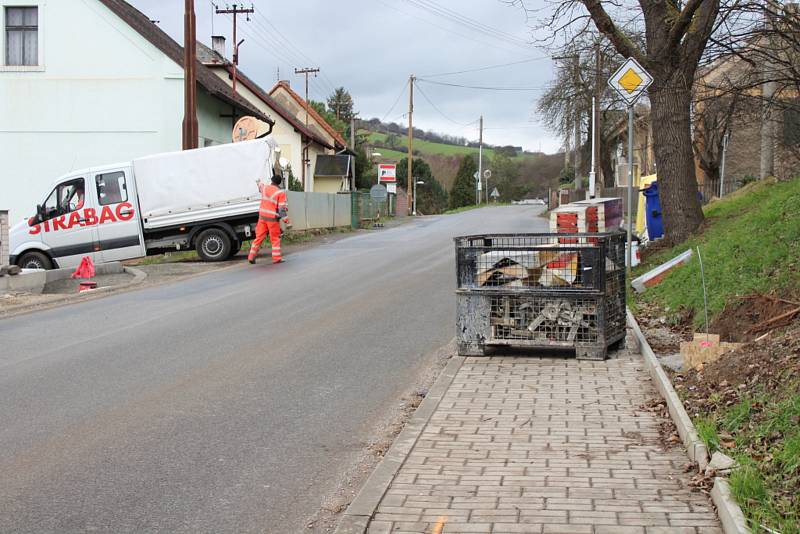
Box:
[678,342,800,534]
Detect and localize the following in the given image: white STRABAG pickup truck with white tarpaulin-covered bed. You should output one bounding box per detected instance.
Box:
[9,139,278,269]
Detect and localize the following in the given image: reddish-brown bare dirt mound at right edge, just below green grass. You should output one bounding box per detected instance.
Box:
[709,294,800,343]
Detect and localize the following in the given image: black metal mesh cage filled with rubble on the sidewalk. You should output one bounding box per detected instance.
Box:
[456,232,625,359]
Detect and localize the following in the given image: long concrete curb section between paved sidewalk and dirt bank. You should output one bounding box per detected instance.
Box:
[626,309,709,471]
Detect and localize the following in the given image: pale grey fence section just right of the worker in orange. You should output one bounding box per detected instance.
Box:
[288,191,352,230]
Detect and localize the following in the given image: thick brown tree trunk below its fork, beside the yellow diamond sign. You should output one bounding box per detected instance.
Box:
[649,82,703,243]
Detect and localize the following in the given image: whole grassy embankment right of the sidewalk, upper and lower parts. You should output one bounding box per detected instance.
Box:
[632,179,800,534]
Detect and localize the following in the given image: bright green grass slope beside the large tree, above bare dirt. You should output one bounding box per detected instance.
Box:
[632,179,800,325]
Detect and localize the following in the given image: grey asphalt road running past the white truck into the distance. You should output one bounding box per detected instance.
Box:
[0,206,546,533]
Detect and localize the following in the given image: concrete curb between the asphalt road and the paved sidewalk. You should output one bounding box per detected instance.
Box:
[334,356,464,534]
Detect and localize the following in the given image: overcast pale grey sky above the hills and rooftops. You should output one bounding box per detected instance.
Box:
[128,0,560,152]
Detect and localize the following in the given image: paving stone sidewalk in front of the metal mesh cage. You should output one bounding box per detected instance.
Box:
[368,344,722,534]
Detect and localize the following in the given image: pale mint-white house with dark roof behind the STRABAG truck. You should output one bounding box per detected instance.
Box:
[0,0,272,221]
